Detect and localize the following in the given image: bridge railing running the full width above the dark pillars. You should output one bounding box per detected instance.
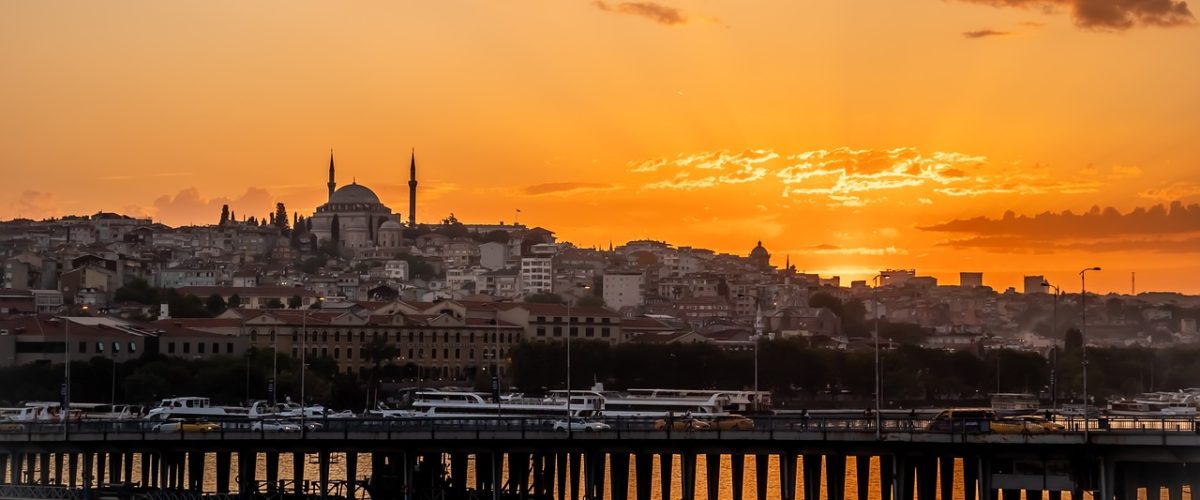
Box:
[0,414,1198,440]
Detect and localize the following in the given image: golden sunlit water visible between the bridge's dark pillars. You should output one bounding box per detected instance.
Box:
[0,453,1192,500]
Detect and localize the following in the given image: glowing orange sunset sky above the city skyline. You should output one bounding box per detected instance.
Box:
[0,0,1200,294]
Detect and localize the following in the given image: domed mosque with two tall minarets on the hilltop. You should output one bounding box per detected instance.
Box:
[312,151,416,251]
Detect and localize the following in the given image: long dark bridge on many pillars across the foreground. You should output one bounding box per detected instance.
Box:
[0,415,1200,500]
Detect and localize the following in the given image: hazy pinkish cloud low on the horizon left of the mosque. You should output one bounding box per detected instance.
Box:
[154,187,275,225]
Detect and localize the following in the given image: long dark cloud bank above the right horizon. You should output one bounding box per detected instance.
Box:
[920,201,1200,241]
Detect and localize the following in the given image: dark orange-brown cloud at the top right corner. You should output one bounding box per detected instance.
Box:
[959,0,1195,31]
